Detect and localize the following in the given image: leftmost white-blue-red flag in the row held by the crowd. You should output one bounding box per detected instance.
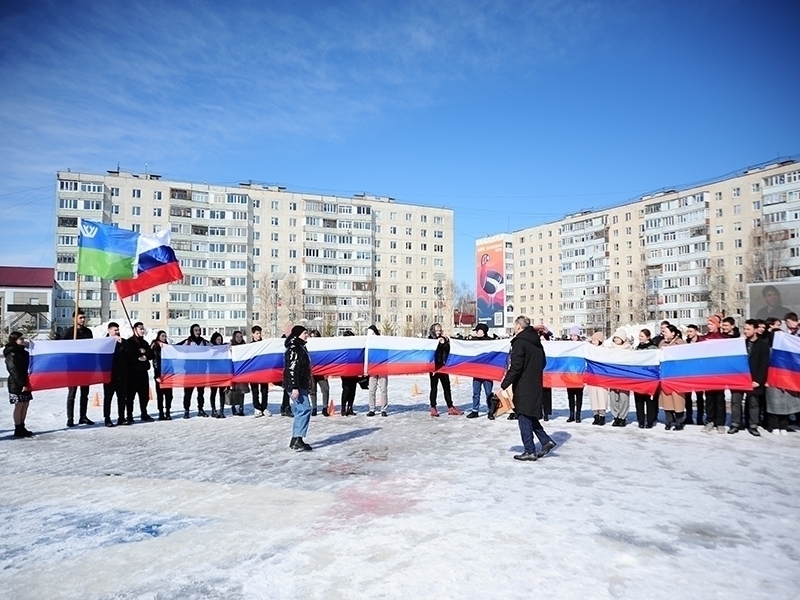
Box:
[30,338,117,391]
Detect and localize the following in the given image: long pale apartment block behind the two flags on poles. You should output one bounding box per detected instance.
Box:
[55,170,454,339]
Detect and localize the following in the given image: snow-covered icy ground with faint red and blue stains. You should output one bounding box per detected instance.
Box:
[0,376,800,599]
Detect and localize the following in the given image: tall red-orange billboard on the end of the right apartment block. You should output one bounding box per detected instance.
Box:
[475,238,506,327]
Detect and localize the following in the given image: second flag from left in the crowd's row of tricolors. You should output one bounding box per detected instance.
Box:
[161,344,233,388]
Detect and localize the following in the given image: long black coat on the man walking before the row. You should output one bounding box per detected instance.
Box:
[500,327,547,419]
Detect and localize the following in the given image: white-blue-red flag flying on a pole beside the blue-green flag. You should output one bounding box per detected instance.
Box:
[115,230,183,298]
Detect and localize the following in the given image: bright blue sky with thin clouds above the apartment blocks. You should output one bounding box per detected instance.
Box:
[0,0,800,284]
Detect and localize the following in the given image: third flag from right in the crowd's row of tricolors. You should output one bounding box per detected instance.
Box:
[584,344,659,394]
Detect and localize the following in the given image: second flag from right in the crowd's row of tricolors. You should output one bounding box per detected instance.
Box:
[660,338,753,394]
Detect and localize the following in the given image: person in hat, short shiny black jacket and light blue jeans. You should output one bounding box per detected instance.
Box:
[283,325,312,452]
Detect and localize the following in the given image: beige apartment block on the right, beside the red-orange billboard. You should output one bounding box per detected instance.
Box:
[479,159,800,335]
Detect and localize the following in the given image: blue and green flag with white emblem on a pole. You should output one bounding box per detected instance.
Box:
[78,219,140,279]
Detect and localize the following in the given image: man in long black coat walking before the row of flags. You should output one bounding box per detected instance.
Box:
[500,316,556,460]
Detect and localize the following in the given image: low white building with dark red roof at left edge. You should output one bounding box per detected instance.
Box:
[0,267,55,339]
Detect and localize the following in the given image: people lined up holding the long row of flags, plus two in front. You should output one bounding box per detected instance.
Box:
[4,311,800,460]
